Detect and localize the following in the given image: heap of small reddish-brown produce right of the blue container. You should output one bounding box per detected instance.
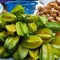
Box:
[37,1,60,22]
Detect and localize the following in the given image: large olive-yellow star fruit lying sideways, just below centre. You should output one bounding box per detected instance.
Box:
[22,35,43,49]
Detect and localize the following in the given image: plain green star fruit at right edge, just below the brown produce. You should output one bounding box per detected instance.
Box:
[46,22,60,32]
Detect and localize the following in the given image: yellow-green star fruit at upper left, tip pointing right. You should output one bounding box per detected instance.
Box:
[1,12,16,22]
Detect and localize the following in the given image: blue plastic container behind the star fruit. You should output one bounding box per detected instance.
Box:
[5,1,37,14]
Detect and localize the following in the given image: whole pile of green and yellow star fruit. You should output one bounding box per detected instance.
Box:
[0,5,60,60]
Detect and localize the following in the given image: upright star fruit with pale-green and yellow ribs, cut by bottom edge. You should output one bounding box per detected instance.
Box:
[40,43,54,60]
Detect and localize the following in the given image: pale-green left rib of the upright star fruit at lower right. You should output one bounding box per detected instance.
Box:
[40,44,49,60]
